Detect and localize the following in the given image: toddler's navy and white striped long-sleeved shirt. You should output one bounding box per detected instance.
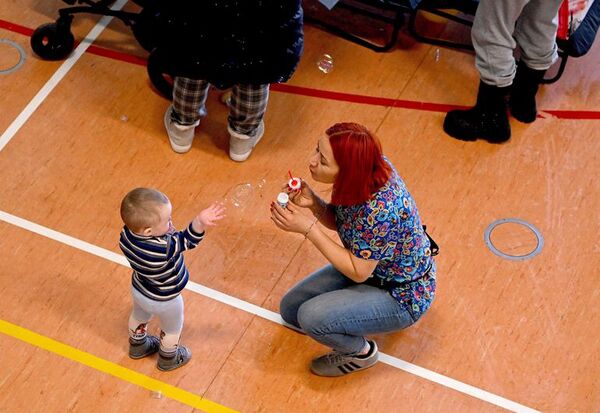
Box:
[119,223,204,301]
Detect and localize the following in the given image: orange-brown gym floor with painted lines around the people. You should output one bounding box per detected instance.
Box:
[0,0,600,413]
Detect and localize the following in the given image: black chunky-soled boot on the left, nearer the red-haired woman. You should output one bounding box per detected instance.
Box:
[444,81,510,143]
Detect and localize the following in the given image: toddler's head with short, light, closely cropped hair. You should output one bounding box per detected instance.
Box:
[121,188,173,236]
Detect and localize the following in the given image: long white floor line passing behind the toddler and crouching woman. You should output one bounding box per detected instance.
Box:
[0,211,540,413]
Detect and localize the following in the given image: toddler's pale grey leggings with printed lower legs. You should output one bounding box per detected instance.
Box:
[129,287,183,353]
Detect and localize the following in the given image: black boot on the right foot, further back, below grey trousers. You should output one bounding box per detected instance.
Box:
[508,61,546,123]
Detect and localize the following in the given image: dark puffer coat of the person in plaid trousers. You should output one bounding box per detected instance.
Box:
[155,0,304,89]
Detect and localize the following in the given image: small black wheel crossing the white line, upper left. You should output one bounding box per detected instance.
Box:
[30,23,75,60]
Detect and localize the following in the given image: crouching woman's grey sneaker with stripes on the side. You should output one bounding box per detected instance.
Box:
[310,340,379,377]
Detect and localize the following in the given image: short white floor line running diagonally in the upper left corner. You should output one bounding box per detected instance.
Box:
[0,0,128,151]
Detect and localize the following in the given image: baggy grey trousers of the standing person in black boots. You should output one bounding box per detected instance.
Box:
[471,0,562,87]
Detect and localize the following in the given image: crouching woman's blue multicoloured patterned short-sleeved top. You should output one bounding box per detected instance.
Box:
[335,159,436,314]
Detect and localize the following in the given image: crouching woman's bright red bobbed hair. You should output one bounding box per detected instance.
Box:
[325,122,392,206]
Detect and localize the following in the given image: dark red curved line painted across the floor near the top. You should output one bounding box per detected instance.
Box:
[0,19,600,120]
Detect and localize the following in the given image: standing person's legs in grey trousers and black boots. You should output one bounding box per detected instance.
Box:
[444,0,561,143]
